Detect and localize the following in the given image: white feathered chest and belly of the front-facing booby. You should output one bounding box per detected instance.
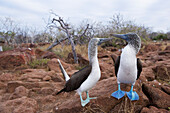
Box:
[117,45,137,83]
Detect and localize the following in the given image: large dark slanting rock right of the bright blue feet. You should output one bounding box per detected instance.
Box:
[142,83,170,109]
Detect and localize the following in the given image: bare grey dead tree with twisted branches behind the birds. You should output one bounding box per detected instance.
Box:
[47,13,93,63]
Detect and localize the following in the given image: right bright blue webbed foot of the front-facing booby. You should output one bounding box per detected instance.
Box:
[126,85,139,101]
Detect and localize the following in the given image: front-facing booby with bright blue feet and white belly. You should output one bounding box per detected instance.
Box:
[111,33,142,101]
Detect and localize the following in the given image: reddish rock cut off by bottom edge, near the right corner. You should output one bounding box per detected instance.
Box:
[141,106,168,113]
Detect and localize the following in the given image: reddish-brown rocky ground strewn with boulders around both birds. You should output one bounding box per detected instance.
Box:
[0,42,170,113]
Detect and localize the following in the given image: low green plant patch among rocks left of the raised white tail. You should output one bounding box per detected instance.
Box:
[28,59,50,68]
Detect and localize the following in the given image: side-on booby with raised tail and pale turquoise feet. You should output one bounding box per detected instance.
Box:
[57,38,113,106]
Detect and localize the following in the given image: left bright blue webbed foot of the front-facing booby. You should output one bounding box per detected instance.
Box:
[111,84,125,99]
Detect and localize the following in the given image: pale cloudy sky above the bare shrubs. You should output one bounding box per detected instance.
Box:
[0,0,170,32]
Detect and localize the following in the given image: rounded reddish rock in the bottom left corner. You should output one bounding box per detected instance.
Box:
[0,97,38,113]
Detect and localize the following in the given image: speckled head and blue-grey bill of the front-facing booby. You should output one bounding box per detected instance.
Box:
[111,33,141,53]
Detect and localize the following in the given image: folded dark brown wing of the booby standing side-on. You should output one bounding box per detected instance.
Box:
[65,65,92,92]
